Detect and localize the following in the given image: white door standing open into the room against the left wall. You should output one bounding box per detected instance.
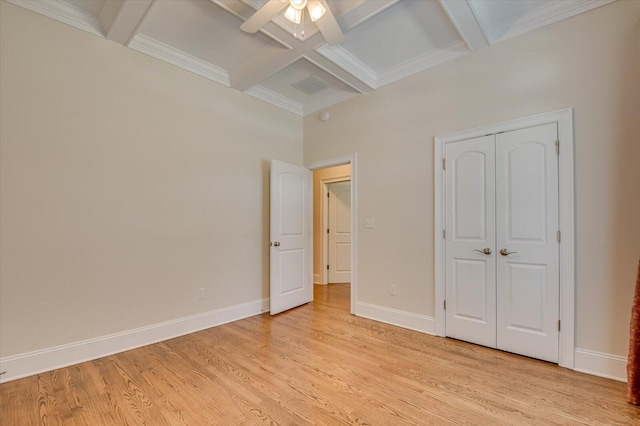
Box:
[269,160,313,315]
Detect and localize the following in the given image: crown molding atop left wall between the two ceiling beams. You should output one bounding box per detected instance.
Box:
[129,34,230,87]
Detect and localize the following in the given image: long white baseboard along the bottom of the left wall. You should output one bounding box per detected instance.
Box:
[0,299,269,383]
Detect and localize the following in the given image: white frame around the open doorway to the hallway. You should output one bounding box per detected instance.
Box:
[306,153,358,315]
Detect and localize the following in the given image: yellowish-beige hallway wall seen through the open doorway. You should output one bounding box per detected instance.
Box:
[313,164,351,284]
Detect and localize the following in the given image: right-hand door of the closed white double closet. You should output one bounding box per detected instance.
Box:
[495,123,559,363]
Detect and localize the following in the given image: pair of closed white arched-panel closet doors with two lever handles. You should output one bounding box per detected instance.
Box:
[445,123,560,363]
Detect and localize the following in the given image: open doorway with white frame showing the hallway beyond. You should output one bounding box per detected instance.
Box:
[308,154,357,315]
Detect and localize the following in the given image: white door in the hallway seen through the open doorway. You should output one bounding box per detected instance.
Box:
[327,181,351,283]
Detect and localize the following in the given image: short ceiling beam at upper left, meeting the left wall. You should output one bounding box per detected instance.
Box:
[99,0,154,46]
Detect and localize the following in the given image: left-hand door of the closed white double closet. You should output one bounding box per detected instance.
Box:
[445,136,496,347]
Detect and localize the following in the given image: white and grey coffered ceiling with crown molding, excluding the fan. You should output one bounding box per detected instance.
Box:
[7,0,613,115]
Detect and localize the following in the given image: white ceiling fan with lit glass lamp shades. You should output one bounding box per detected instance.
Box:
[240,0,344,45]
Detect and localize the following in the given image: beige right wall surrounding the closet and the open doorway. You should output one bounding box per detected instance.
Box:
[304,1,640,356]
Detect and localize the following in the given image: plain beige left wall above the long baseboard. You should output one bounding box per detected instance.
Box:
[0,2,302,357]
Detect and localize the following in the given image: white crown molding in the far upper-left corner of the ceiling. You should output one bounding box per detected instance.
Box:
[7,0,105,38]
